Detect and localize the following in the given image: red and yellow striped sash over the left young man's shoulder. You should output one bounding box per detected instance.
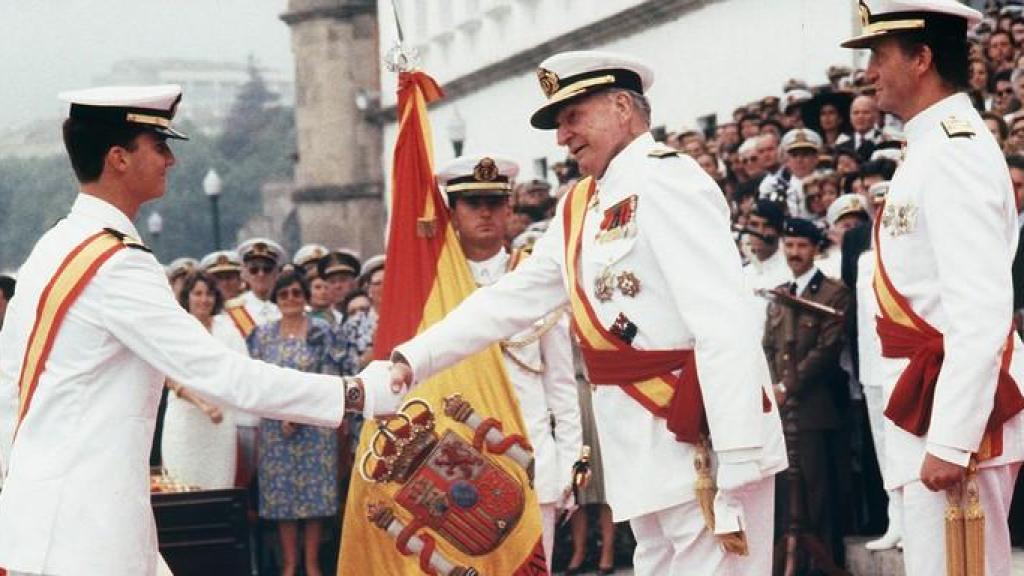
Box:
[14,231,127,435]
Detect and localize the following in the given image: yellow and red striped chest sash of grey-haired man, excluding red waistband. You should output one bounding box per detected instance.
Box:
[562,177,676,417]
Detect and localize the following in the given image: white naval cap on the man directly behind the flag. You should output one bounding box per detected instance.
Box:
[437,154,519,206]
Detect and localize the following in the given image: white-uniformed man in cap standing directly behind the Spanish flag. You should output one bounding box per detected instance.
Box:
[437,155,583,570]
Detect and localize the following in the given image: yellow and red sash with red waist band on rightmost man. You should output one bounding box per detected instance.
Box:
[871,205,1024,460]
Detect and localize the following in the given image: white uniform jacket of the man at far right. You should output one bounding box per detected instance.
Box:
[876,93,1024,488]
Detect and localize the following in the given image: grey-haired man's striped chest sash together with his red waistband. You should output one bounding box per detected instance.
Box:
[563,177,771,444]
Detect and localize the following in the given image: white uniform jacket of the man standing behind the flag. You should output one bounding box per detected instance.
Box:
[469,250,583,504]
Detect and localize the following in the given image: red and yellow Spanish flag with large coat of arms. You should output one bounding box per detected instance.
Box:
[338,71,547,576]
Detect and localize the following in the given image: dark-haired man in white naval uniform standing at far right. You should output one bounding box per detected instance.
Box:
[843,0,1024,576]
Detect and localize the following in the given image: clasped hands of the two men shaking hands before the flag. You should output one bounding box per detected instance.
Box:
[345,360,413,414]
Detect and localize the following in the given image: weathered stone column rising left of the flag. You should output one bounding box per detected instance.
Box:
[281,0,385,257]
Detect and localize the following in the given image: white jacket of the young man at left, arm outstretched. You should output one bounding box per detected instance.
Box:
[0,194,344,576]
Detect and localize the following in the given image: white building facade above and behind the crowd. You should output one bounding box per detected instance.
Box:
[377,0,862,182]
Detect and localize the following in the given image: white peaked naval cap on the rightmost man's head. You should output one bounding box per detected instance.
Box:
[841,0,982,48]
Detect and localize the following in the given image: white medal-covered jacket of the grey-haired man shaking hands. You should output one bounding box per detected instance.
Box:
[396,134,786,521]
